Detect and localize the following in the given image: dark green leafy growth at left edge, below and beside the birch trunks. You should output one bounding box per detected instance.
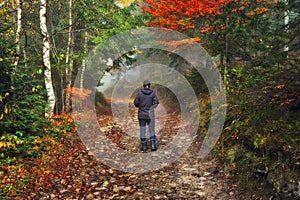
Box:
[0,34,51,163]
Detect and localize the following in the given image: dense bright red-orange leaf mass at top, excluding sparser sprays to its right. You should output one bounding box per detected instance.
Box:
[140,0,232,31]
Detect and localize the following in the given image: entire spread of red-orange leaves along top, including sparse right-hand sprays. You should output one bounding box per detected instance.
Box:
[140,0,278,32]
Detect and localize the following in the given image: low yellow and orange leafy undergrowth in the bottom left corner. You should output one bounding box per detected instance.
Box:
[0,113,74,199]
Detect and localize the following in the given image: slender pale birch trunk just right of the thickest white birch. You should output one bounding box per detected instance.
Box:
[65,0,74,112]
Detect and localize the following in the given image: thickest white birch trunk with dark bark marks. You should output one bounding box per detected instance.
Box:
[40,0,55,117]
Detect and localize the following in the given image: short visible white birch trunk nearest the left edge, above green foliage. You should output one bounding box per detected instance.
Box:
[14,0,23,66]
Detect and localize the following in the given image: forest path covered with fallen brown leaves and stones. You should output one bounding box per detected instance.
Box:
[30,99,243,200]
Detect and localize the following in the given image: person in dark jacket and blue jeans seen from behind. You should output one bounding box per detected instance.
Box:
[133,80,159,152]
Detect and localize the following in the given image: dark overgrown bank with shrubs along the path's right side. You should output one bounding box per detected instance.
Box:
[216,65,300,199]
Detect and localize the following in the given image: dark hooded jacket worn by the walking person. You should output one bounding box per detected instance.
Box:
[133,88,159,119]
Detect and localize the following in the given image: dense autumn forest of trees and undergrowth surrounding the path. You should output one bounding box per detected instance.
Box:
[0,0,300,199]
